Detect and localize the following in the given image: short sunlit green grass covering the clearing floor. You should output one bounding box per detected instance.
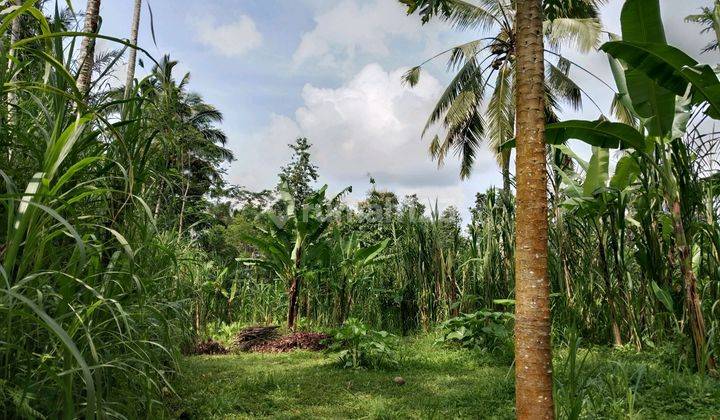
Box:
[174,337,720,419]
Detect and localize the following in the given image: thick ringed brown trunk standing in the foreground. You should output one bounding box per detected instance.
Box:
[515,0,555,419]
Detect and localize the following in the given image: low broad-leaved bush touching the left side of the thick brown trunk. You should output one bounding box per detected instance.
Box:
[437,310,515,354]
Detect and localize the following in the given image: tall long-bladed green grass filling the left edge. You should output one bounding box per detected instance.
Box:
[0,2,197,418]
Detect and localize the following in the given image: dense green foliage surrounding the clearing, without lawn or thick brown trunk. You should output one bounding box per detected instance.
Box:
[0,0,720,418]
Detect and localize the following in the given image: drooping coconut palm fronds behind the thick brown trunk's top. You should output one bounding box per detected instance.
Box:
[400,0,605,193]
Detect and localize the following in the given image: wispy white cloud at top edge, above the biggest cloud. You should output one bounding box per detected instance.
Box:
[293,0,427,66]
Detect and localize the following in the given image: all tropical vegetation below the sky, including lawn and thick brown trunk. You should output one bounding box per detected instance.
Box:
[0,0,720,419]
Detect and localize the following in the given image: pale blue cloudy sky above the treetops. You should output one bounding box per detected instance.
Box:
[79,0,717,220]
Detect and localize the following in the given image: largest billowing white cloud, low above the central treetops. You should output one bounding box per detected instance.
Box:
[233,64,499,215]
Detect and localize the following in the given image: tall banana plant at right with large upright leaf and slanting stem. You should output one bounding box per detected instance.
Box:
[556,0,720,371]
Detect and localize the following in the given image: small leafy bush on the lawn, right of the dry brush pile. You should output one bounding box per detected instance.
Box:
[328,318,399,369]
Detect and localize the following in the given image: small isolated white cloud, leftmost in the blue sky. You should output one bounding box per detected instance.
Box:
[195,15,263,57]
